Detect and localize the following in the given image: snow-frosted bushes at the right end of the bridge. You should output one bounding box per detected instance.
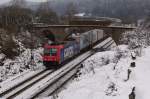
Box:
[120,19,150,49]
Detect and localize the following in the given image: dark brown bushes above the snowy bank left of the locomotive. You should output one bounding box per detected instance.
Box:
[0,29,44,59]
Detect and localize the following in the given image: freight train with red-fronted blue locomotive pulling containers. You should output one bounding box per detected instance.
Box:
[43,29,107,68]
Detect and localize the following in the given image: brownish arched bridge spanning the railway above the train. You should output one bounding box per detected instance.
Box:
[31,24,136,43]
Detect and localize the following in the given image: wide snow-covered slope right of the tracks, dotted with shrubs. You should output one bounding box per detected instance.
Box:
[58,45,150,99]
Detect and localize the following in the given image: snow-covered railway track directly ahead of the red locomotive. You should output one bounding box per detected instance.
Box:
[0,70,53,99]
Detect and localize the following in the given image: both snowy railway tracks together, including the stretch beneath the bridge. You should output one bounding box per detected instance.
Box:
[0,37,113,99]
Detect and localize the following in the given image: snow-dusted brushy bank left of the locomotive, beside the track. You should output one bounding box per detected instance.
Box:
[0,48,43,82]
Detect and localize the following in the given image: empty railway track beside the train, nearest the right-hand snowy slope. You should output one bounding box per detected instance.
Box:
[33,52,91,99]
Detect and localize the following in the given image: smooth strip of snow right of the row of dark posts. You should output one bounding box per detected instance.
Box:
[134,47,150,99]
